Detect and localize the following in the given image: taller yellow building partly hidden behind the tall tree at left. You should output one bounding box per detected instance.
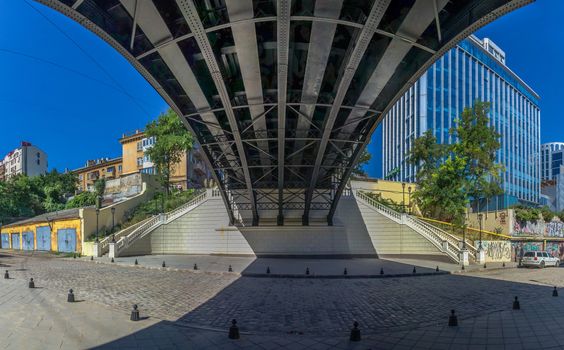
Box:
[119,130,210,189]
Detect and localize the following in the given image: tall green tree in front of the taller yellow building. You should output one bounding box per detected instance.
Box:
[146,109,194,193]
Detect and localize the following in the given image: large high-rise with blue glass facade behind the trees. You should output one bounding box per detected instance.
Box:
[382,36,541,208]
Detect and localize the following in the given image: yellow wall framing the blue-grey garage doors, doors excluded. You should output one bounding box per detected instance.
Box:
[2,219,82,252]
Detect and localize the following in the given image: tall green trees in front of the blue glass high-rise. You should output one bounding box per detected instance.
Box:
[409,101,503,227]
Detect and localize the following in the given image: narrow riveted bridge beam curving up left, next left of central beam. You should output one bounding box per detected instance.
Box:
[176,0,259,226]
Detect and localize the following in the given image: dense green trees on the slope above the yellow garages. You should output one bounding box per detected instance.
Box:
[0,170,78,222]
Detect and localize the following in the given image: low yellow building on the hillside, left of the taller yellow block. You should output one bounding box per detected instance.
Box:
[73,157,123,192]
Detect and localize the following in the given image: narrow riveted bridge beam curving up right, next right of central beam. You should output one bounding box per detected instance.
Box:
[302,0,390,225]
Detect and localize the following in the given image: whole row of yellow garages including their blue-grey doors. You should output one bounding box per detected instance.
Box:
[1,209,83,253]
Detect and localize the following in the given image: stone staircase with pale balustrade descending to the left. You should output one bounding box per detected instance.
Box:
[106,191,211,258]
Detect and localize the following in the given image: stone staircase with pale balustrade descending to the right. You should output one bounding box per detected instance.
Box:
[354,190,477,264]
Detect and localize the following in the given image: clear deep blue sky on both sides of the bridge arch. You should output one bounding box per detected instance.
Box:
[0,0,564,177]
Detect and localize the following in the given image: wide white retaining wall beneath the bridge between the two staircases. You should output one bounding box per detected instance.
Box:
[120,191,443,256]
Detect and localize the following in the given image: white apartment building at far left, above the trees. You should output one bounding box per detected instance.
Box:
[0,141,48,180]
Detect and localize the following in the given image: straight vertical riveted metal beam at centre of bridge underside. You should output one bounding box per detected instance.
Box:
[276,0,291,226]
